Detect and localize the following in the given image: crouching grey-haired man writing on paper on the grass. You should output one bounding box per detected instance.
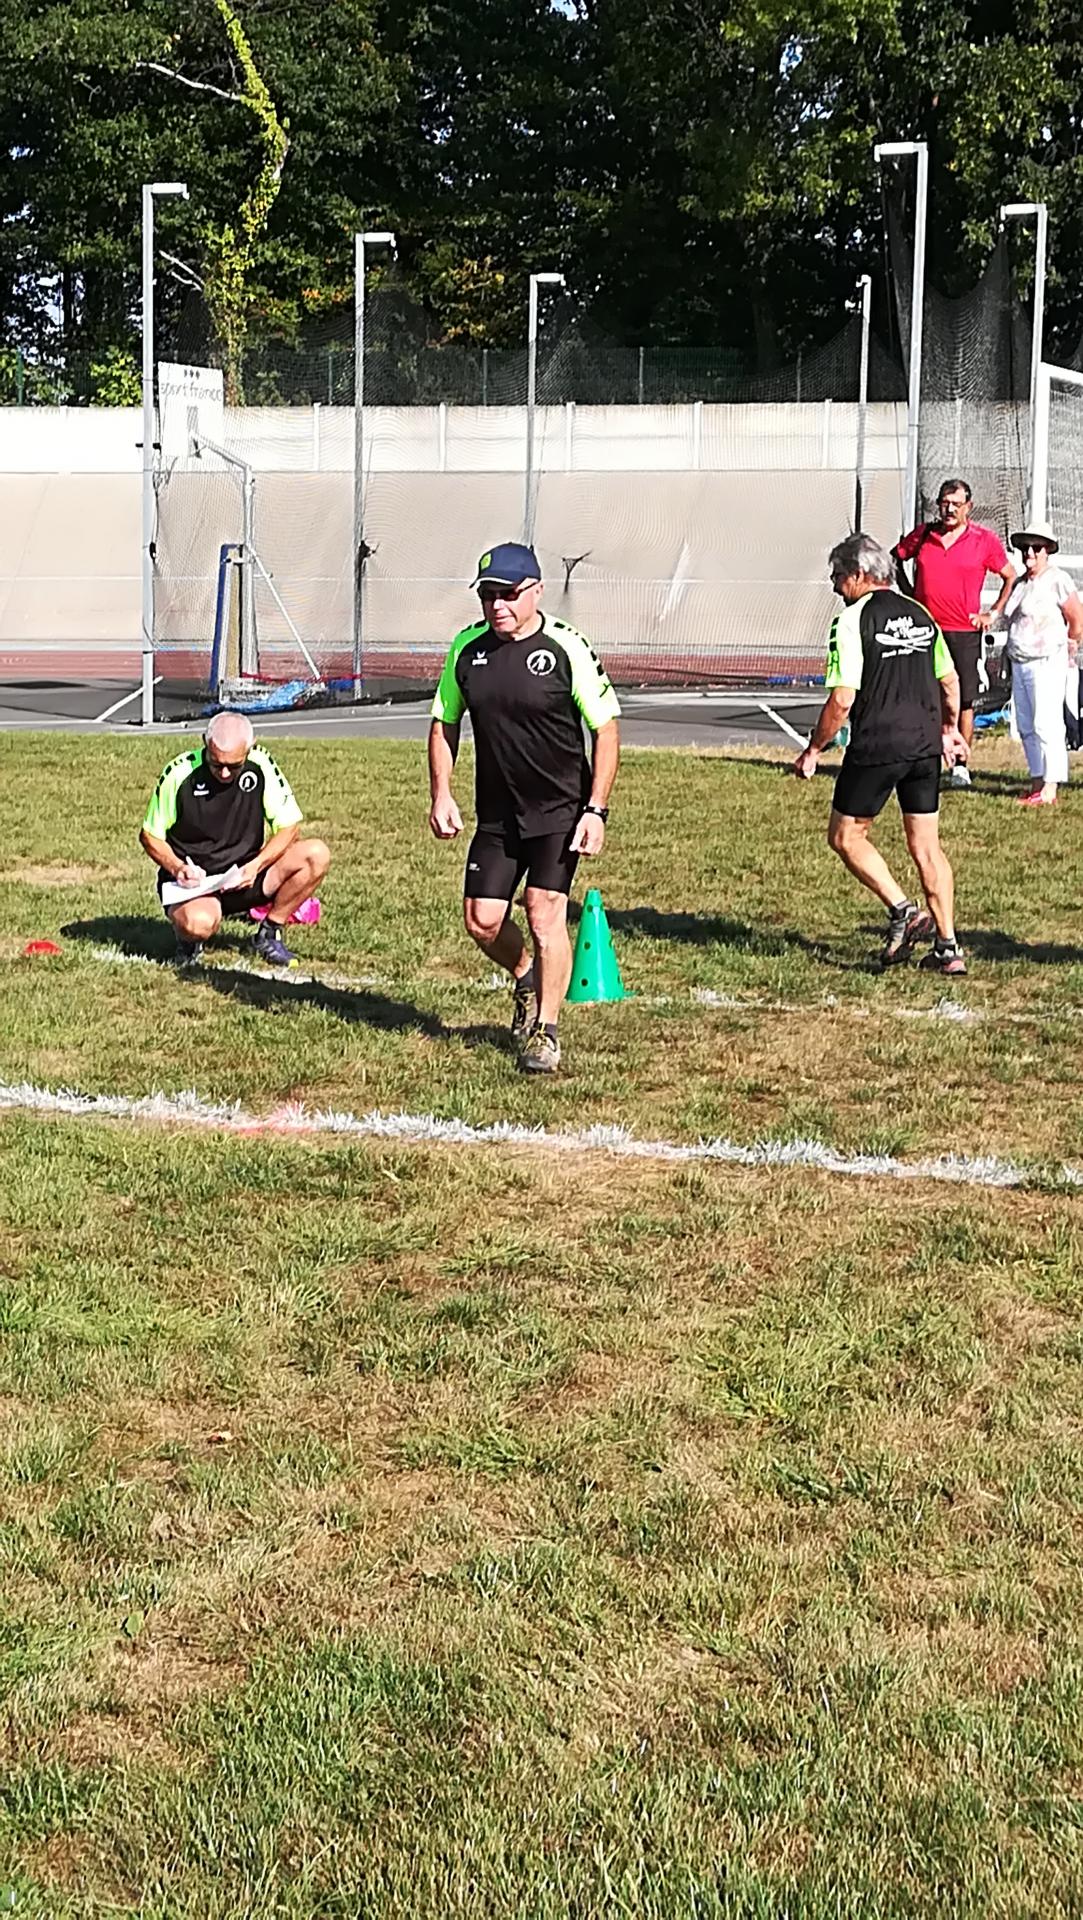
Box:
[138,714,330,968]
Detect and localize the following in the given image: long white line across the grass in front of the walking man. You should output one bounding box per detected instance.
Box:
[0,1081,1083,1187]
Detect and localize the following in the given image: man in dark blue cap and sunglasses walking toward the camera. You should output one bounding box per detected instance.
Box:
[428,541,620,1073]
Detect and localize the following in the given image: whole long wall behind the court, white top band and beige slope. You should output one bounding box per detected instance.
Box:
[0,401,1044,691]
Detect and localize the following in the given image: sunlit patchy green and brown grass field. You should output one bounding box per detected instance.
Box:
[0,735,1083,1920]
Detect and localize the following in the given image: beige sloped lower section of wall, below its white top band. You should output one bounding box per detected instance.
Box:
[0,468,899,666]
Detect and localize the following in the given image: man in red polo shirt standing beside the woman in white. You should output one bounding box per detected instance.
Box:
[895,480,1016,787]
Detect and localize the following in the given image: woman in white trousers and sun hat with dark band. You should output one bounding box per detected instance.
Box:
[1004,520,1083,806]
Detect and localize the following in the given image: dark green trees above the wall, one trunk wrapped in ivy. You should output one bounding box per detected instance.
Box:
[0,0,1083,397]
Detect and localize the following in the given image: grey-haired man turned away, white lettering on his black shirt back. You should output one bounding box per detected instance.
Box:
[793,534,968,975]
